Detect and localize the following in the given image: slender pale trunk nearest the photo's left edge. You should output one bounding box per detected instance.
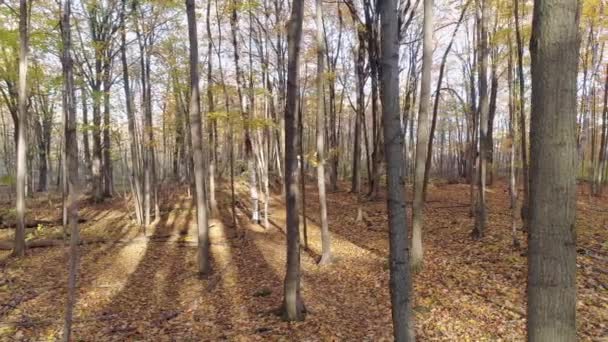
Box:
[13,0,29,256]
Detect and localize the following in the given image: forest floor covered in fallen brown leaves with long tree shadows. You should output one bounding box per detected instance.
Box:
[0,178,608,341]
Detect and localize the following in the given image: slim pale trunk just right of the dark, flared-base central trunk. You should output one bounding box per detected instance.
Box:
[314,0,331,264]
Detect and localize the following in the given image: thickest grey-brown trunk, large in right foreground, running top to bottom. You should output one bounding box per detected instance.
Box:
[527,0,580,341]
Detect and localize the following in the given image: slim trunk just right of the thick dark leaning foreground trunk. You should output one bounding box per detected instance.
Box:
[410,0,438,272]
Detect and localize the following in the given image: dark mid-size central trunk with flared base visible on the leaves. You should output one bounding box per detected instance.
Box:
[283,0,306,321]
